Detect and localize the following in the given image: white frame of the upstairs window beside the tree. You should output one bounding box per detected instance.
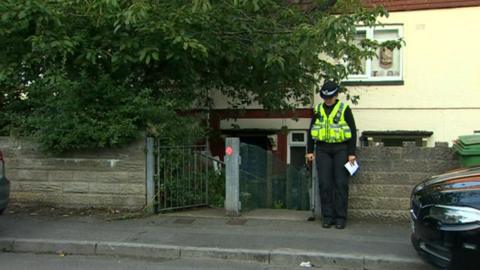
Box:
[345,24,404,82]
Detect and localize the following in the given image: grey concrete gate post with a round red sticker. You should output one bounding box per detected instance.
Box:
[224,138,241,216]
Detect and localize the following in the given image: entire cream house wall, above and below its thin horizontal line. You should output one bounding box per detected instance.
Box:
[342,7,480,146]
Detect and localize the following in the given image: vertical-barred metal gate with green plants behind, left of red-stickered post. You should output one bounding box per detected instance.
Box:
[153,139,209,212]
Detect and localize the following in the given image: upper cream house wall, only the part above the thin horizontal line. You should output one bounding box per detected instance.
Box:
[344,7,480,108]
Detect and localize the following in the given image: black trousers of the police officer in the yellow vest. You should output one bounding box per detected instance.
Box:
[315,143,349,222]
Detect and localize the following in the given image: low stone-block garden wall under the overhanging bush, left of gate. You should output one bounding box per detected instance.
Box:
[0,137,146,209]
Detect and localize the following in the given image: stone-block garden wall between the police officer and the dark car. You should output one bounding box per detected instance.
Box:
[349,143,459,221]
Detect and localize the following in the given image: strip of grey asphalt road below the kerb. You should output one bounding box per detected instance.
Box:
[0,252,347,270]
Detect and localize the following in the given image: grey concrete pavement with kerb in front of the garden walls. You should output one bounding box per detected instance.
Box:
[0,209,433,270]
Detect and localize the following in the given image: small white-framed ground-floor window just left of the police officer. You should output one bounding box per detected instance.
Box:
[287,131,307,168]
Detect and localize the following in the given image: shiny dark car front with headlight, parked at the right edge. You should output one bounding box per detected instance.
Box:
[410,167,480,270]
